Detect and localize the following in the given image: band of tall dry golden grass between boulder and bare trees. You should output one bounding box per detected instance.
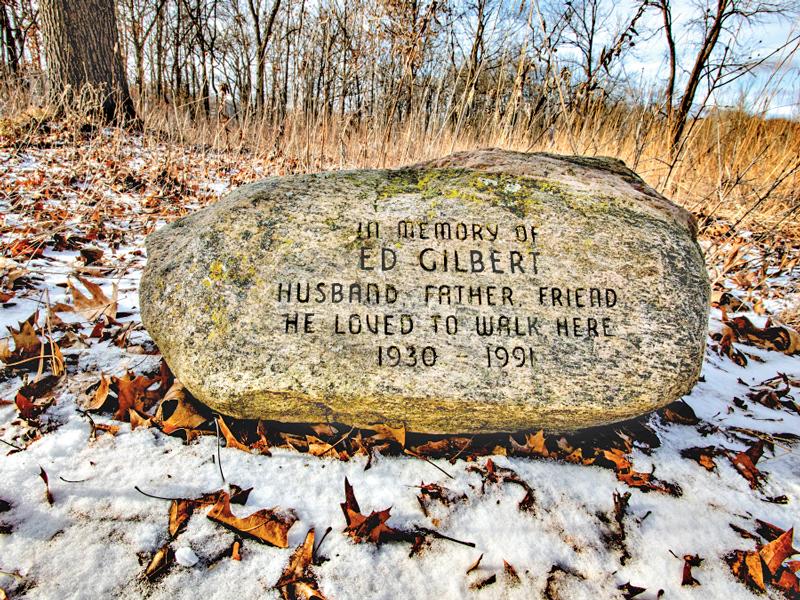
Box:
[0,81,800,237]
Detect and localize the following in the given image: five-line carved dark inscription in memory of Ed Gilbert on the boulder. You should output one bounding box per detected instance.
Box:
[274,213,620,369]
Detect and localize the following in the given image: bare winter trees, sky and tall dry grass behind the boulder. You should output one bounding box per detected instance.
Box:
[0,0,800,229]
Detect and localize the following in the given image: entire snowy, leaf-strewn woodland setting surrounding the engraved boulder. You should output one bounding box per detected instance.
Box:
[0,0,800,600]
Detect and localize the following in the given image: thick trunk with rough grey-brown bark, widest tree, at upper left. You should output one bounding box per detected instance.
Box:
[40,0,136,122]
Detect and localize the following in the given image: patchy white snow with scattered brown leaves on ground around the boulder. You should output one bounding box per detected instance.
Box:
[0,127,800,599]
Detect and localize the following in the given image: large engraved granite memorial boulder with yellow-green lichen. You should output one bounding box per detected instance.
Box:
[140,150,709,433]
